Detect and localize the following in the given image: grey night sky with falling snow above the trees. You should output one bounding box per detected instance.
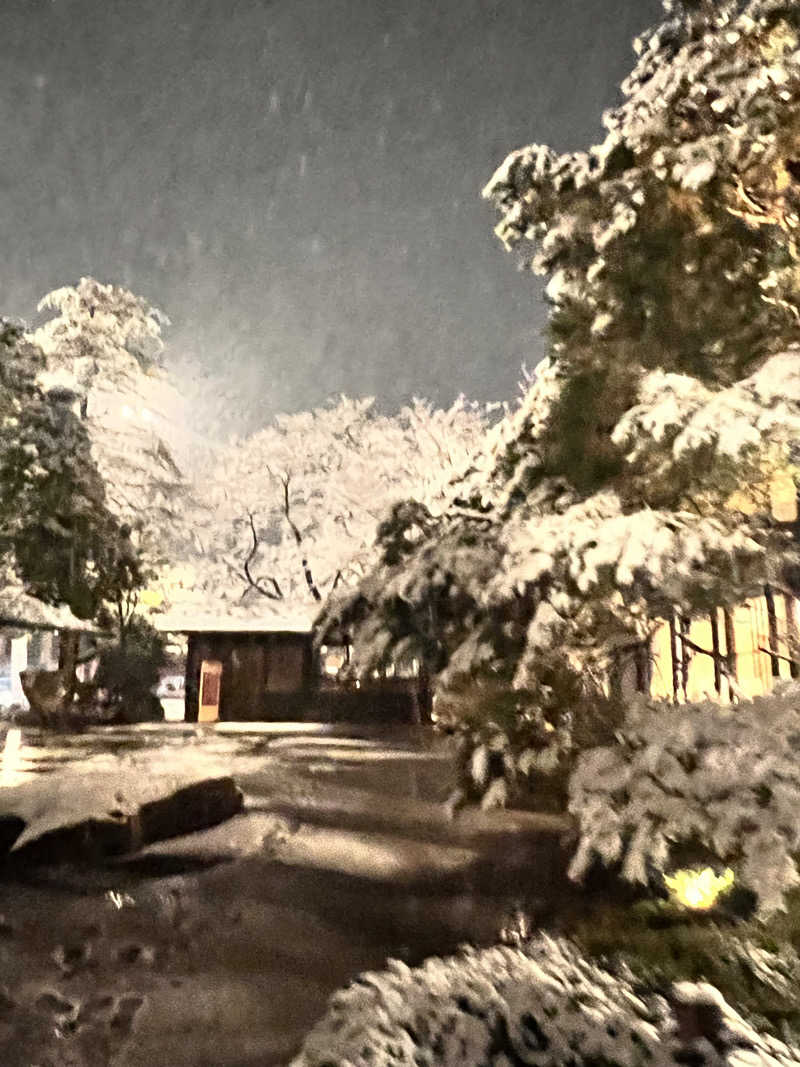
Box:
[0,0,660,433]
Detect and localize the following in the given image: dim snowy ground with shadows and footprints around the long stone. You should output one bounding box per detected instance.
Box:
[0,723,562,1067]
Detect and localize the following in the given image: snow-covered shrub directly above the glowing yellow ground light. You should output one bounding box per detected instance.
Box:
[570,683,800,917]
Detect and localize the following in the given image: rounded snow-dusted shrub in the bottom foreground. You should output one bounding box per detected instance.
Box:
[292,936,800,1067]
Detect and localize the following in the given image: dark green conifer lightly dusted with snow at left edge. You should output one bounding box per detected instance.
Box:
[0,320,141,707]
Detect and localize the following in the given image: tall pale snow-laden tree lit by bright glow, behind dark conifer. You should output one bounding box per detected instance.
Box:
[13,277,192,714]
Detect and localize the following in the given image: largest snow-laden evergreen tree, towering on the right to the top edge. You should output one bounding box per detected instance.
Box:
[323,0,800,768]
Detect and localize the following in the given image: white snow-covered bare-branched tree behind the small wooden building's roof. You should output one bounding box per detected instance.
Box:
[157,397,492,615]
